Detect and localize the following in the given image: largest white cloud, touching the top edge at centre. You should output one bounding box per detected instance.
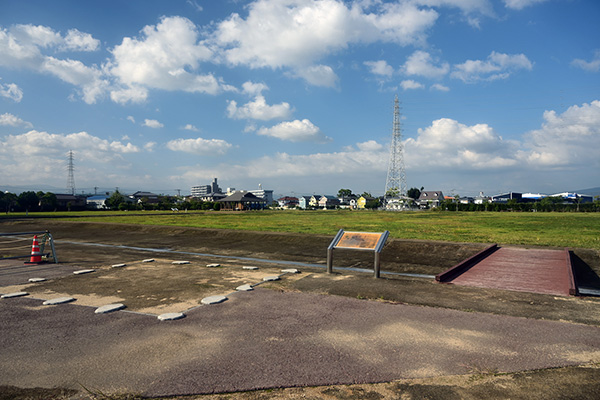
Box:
[214,0,438,87]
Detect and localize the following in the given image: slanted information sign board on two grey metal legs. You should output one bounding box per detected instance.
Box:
[327,229,390,278]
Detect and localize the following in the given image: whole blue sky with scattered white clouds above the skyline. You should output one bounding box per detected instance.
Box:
[0,0,600,195]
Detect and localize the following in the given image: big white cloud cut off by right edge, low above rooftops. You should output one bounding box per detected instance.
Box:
[521,100,600,171]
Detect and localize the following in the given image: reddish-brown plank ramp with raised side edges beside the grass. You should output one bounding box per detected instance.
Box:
[436,245,577,296]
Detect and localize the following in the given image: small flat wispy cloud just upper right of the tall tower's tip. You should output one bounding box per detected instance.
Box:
[450,51,533,83]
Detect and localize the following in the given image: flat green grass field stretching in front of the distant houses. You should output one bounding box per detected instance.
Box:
[23,211,600,250]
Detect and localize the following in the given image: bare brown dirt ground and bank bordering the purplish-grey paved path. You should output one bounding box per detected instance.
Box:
[0,219,600,400]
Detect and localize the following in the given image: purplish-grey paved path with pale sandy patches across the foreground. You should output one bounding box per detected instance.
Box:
[0,289,600,396]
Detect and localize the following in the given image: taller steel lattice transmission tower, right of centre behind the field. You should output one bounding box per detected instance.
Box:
[385,95,407,197]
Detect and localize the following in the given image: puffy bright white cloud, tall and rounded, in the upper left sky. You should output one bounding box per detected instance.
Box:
[108,17,222,94]
